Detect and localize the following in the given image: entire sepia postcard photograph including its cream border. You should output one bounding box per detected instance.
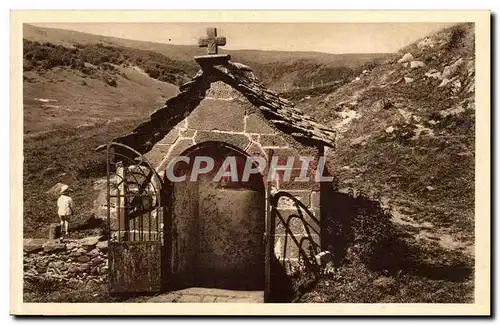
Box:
[11,11,490,315]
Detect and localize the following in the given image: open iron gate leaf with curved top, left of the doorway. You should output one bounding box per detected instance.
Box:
[107,142,164,293]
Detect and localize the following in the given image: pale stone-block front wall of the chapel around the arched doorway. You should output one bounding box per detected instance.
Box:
[145,81,320,260]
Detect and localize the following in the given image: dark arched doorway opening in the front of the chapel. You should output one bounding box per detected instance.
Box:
[166,142,265,290]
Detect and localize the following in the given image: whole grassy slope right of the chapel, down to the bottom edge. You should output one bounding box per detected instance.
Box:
[294,24,475,302]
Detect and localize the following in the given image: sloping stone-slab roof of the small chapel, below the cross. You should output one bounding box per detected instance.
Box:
[97,59,335,154]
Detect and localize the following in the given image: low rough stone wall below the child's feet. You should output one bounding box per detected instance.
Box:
[23,237,108,283]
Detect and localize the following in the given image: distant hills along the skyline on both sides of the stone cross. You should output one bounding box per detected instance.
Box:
[23,24,387,91]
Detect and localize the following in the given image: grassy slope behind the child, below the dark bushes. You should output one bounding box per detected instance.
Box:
[23,67,178,236]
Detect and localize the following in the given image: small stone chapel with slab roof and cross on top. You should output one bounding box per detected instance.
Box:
[97,29,335,298]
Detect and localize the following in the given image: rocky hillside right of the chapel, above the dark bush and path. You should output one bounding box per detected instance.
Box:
[299,25,475,235]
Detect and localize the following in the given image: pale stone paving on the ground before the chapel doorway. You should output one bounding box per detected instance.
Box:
[147,288,264,303]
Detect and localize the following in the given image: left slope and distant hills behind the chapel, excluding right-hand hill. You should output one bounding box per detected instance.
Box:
[23,25,380,234]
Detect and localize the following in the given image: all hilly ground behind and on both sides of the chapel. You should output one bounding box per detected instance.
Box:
[23,24,475,302]
